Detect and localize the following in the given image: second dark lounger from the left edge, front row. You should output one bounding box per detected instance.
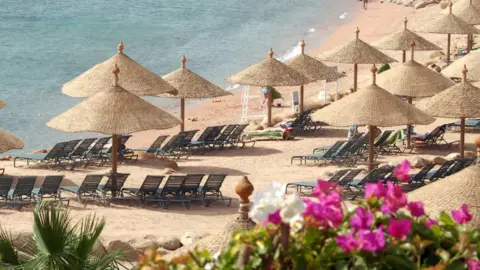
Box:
[7,176,37,209]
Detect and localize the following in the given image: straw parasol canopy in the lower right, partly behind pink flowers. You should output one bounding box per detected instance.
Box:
[407,165,480,225]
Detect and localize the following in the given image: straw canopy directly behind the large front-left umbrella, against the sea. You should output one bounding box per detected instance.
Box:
[62,42,175,98]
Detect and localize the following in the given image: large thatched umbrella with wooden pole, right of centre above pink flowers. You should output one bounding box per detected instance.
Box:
[312,64,435,169]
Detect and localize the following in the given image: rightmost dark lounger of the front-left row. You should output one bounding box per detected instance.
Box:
[198,174,232,207]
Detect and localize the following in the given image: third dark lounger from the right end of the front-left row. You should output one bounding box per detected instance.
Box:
[157,175,192,209]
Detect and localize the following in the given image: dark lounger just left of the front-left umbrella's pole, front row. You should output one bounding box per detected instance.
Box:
[60,174,108,207]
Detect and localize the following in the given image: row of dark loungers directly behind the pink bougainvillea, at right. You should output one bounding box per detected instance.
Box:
[285,158,476,195]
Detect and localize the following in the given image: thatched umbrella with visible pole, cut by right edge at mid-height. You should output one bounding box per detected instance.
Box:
[422,66,480,158]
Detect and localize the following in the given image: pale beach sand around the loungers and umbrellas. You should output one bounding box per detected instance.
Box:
[0,1,477,247]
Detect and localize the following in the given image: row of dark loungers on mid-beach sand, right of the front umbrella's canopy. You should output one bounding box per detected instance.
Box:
[134,124,255,159]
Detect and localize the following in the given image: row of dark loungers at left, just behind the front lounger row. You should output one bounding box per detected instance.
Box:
[13,135,138,170]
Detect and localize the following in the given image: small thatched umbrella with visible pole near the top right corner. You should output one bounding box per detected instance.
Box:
[417,2,480,64]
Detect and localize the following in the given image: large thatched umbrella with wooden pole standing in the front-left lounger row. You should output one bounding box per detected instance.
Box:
[47,65,180,196]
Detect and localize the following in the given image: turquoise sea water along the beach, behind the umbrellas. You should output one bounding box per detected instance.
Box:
[0,0,353,153]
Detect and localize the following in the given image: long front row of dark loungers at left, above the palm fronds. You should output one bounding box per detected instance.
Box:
[0,174,231,208]
